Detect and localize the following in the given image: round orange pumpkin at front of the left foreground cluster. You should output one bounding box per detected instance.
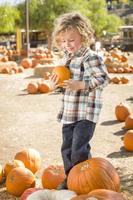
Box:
[6,167,35,197]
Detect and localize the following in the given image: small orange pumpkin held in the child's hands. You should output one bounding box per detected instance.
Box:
[52,66,70,83]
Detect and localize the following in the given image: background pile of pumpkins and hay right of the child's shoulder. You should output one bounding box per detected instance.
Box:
[104,49,133,73]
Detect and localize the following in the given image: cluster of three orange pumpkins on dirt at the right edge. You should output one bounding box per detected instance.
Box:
[115,103,133,151]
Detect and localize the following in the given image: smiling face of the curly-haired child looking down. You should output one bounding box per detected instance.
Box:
[60,29,82,53]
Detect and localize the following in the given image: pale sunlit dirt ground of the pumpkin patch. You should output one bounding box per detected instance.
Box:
[0,54,133,200]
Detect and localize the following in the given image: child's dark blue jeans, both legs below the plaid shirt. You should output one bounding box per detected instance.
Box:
[61,120,96,175]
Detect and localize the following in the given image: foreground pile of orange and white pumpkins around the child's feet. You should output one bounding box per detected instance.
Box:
[0,148,124,200]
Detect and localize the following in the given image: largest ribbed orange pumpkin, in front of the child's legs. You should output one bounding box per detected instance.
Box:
[67,158,120,194]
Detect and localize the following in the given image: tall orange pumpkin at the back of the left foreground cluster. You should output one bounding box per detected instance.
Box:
[15,148,41,173]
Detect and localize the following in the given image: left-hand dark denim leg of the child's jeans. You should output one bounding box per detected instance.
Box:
[61,123,74,175]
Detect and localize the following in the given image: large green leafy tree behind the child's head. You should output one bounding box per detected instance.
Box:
[17,0,122,48]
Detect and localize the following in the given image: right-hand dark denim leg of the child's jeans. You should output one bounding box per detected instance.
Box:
[71,120,96,166]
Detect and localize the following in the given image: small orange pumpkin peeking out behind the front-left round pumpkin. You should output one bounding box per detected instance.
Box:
[4,160,25,176]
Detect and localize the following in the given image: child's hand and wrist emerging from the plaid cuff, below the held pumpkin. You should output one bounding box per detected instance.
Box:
[63,79,85,90]
